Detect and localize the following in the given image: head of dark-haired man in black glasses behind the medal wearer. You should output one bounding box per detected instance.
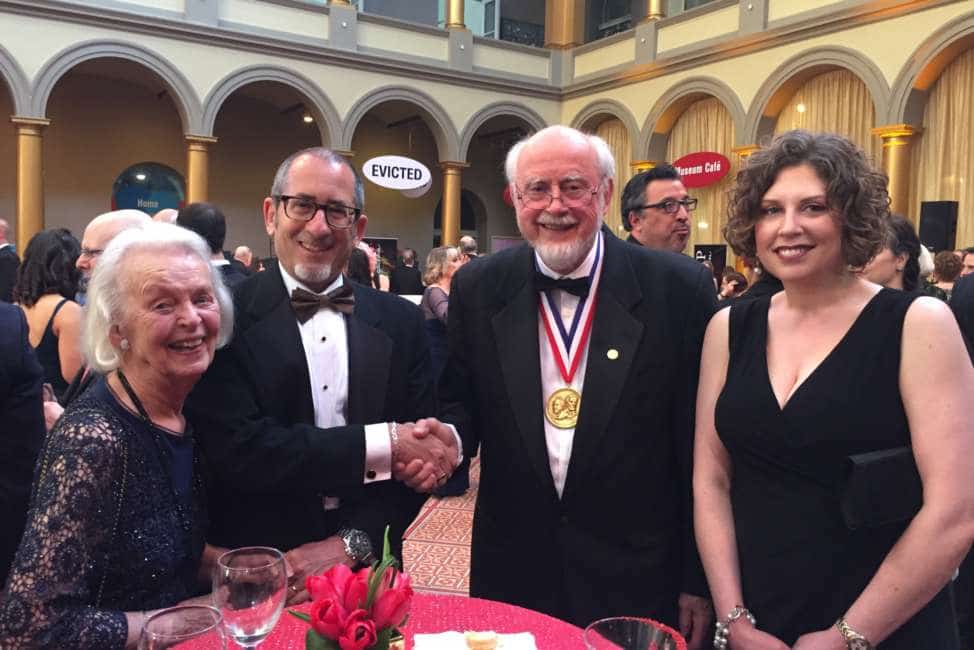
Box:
[621,163,697,253]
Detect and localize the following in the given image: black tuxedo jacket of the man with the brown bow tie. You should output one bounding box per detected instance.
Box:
[186,264,434,553]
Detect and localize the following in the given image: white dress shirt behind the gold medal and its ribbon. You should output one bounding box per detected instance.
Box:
[534,232,602,497]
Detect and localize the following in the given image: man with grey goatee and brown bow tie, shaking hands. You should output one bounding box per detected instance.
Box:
[186,148,459,603]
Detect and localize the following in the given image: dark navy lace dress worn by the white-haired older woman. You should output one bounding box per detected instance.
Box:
[0,378,206,649]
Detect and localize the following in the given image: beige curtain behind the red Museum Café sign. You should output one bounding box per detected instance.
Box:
[666,98,737,256]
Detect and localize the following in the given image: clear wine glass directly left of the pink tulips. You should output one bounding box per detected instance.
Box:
[213,546,287,648]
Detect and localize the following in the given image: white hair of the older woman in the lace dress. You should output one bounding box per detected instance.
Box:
[81,221,233,374]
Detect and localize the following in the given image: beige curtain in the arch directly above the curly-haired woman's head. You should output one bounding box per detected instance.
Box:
[775,70,883,163]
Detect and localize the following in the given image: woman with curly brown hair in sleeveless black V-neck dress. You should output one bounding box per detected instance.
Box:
[694,131,974,650]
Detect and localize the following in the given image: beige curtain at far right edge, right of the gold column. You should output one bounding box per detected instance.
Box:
[911,50,974,248]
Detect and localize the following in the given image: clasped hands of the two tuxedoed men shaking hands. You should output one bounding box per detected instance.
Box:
[392,418,459,492]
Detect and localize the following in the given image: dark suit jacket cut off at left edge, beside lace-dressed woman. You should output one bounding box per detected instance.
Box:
[0,302,44,585]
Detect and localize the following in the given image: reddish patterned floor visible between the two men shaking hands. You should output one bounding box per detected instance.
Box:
[402,458,480,595]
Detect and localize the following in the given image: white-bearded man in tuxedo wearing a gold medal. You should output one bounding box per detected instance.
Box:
[440,126,715,648]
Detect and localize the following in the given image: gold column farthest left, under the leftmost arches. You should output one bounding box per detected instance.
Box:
[10,117,51,247]
